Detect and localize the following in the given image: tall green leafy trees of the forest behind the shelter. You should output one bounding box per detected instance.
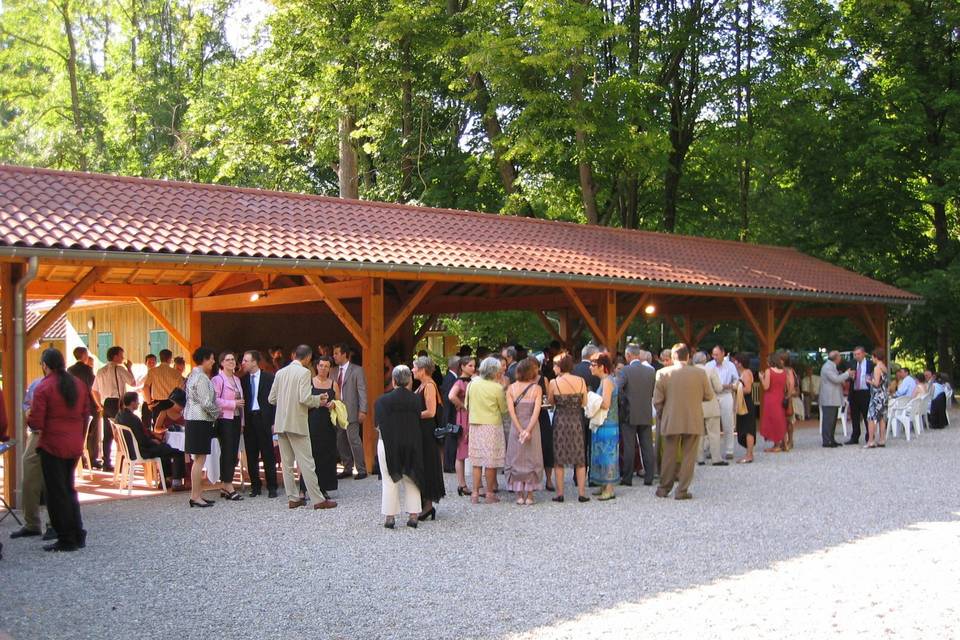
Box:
[0,0,960,372]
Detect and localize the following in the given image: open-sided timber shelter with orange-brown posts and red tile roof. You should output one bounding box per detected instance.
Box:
[0,166,920,500]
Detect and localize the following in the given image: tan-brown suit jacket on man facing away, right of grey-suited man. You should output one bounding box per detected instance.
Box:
[653,363,716,436]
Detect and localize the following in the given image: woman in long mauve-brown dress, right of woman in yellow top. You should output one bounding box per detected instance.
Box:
[506,358,543,505]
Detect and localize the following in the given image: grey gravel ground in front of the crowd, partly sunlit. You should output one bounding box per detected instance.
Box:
[0,418,960,640]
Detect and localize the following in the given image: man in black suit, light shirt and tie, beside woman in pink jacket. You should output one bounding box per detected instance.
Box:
[240,351,277,498]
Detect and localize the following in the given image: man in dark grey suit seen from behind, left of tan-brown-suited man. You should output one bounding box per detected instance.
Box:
[618,344,657,486]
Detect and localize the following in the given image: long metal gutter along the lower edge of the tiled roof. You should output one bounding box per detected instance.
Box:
[0,246,923,305]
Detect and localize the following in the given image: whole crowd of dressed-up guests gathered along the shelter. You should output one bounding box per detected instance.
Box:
[5,336,953,551]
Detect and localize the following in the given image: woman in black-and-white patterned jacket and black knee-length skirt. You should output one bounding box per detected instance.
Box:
[183,347,220,508]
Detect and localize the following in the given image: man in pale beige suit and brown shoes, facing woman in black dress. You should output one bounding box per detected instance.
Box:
[267,344,337,509]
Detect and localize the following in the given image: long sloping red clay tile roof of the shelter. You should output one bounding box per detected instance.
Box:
[0,165,919,302]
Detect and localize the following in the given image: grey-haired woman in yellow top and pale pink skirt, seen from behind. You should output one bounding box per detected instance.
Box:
[464,358,507,504]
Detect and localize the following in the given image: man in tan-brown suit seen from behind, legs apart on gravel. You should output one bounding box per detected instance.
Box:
[653,342,715,500]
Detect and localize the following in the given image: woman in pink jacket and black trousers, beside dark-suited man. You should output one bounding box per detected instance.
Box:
[212,351,244,502]
